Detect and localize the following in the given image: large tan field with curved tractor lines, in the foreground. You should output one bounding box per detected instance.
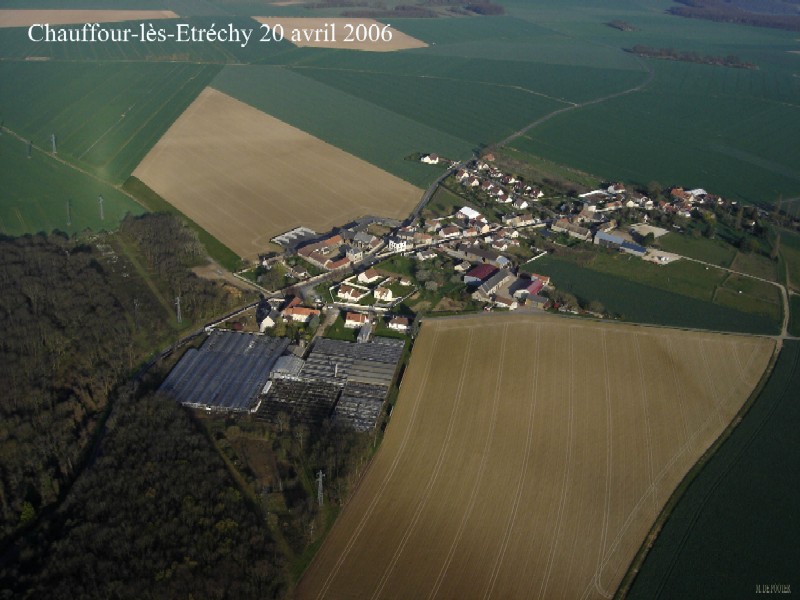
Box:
[296,315,774,600]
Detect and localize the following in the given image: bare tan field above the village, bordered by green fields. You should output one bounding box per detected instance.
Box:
[133,88,422,259]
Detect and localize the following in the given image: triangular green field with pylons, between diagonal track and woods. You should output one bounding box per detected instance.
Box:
[0,132,144,235]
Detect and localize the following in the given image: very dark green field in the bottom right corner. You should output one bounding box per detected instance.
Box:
[627,342,800,600]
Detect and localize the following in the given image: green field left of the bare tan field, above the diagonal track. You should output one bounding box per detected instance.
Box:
[0,62,219,183]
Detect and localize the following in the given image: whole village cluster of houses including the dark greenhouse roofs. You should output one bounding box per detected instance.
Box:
[162,154,749,431]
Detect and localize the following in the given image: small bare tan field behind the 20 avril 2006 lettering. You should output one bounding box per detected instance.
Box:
[253,17,428,52]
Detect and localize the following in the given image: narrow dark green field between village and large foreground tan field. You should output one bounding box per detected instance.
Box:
[524,256,778,333]
